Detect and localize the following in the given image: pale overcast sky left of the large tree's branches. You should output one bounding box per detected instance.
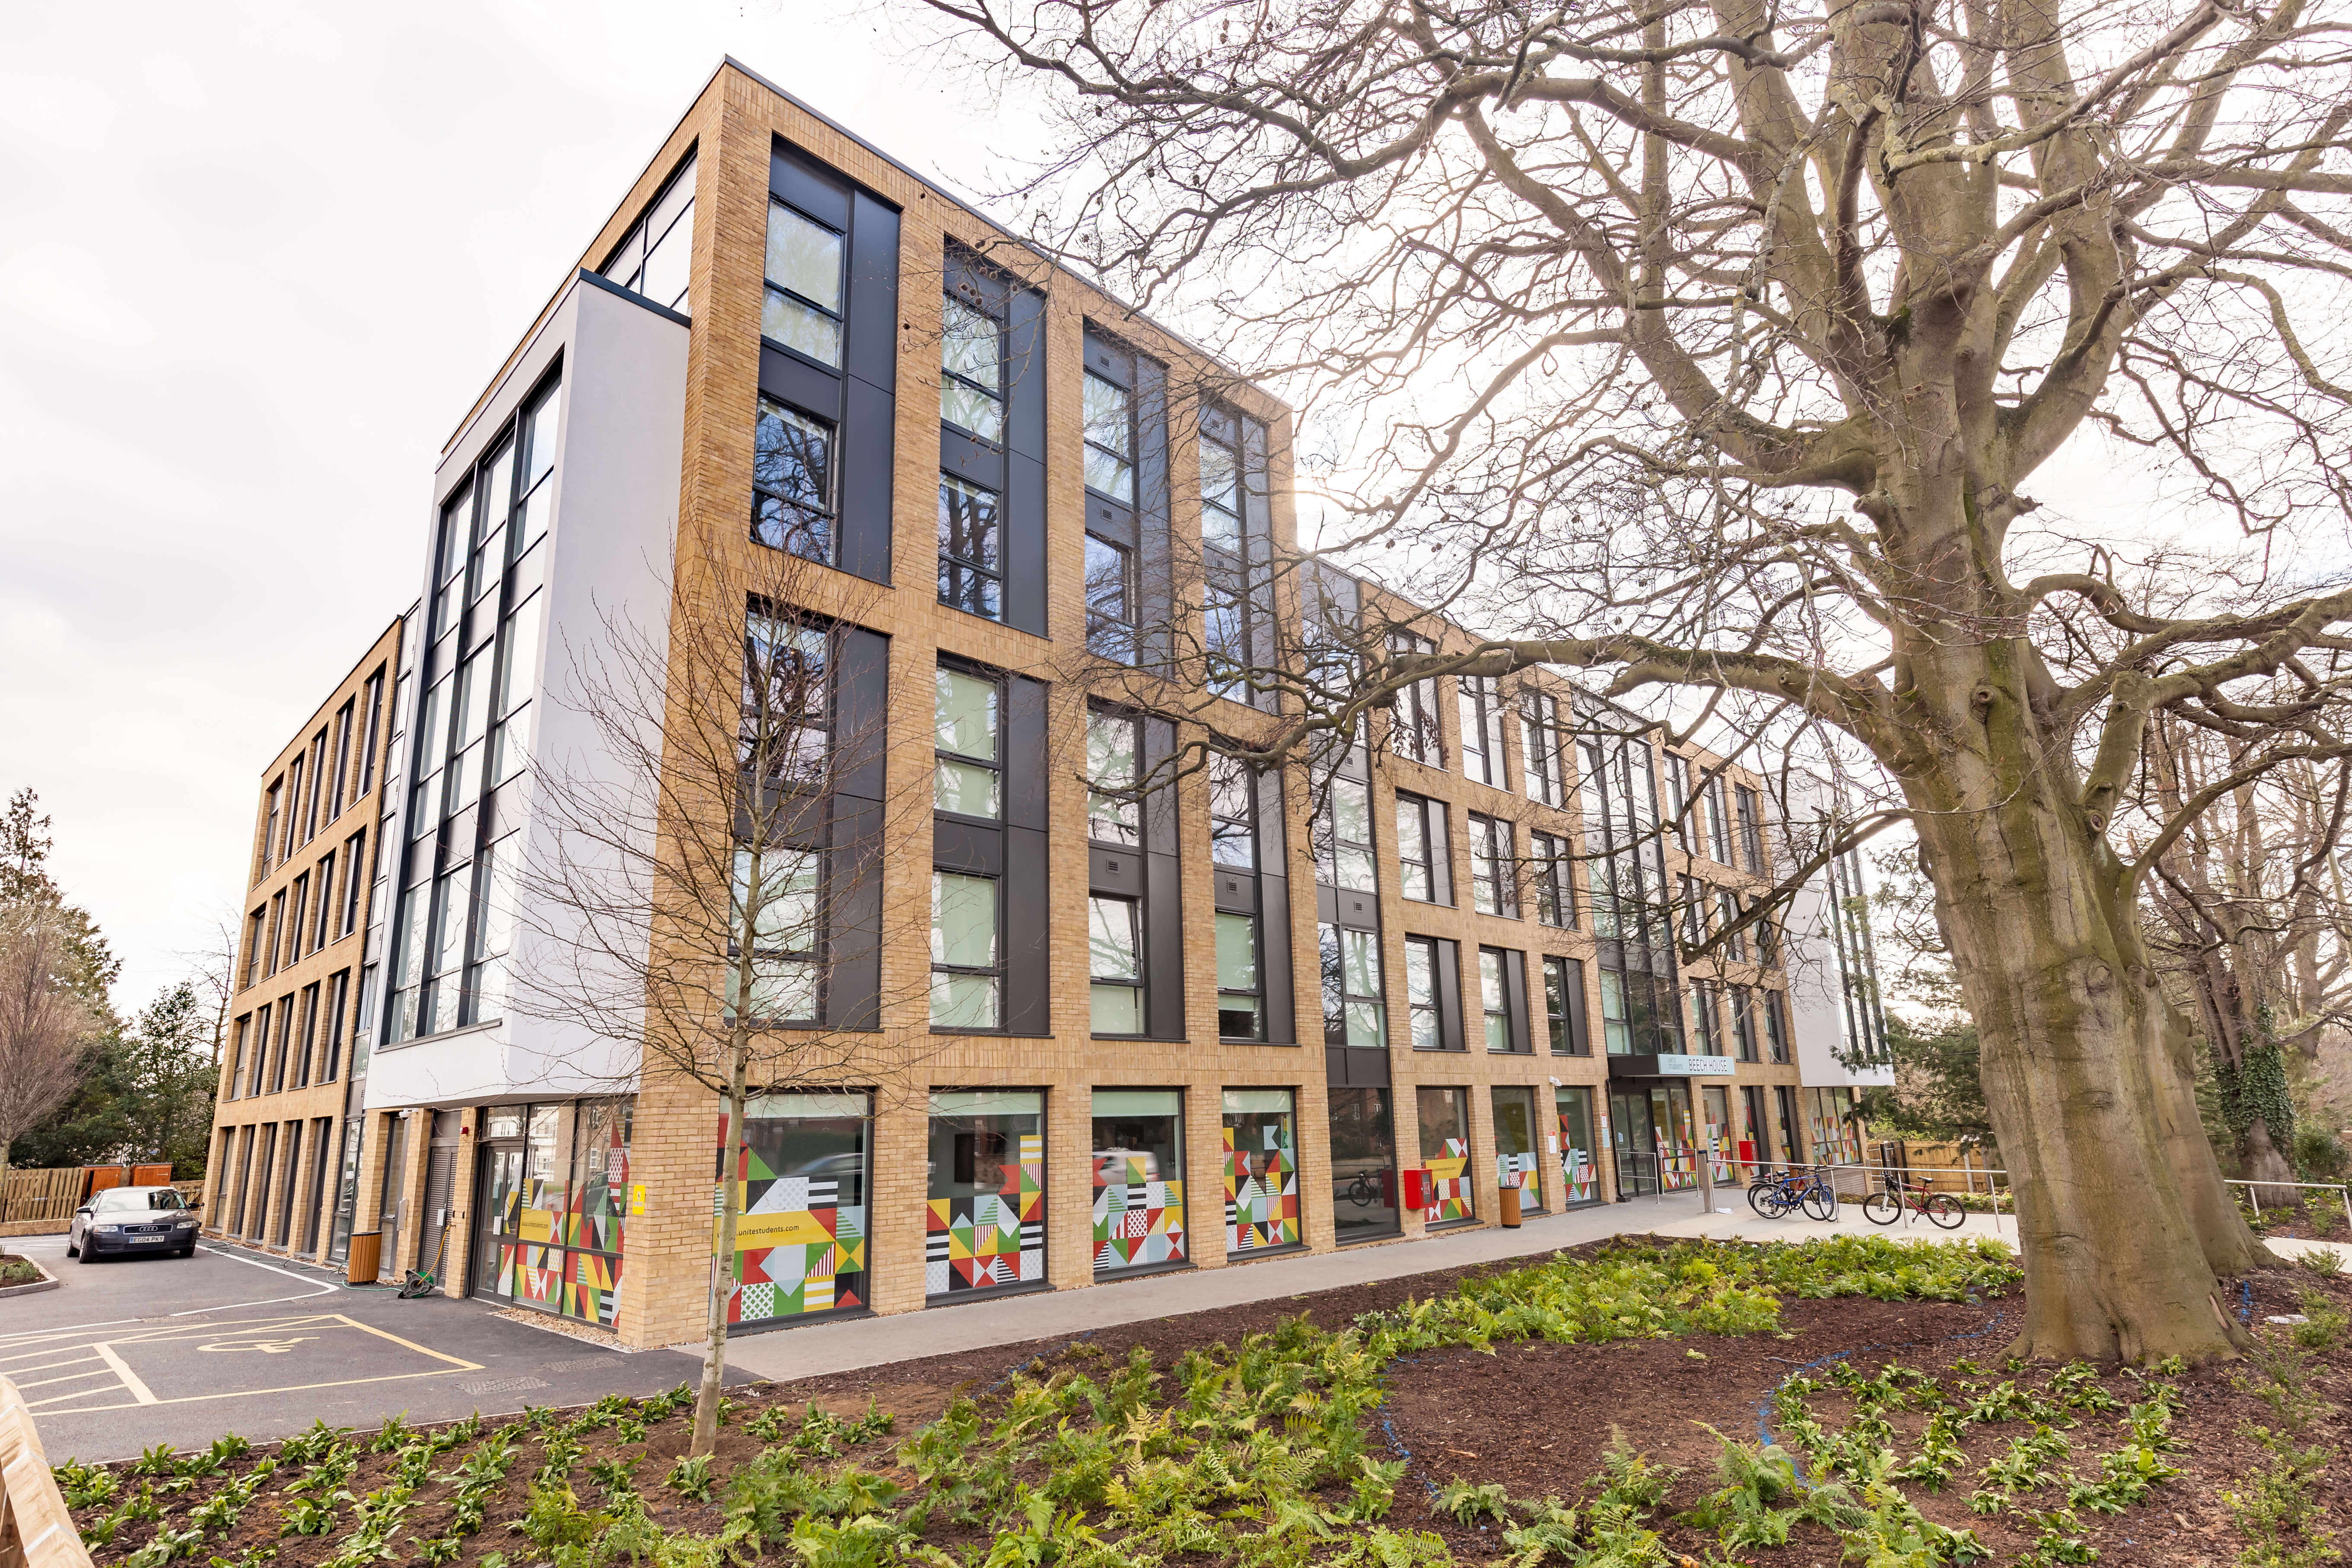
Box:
[0,0,1049,1011]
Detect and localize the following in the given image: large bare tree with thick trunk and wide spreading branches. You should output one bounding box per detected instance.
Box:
[920,0,2352,1359]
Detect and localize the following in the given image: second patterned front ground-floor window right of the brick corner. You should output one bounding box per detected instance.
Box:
[922,1088,1044,1295]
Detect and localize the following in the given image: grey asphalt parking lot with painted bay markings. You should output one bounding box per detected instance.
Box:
[0,1237,734,1462]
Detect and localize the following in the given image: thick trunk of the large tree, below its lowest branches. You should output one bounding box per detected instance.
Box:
[1915,785,2263,1361]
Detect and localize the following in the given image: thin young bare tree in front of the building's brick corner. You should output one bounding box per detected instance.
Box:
[510,534,931,1453]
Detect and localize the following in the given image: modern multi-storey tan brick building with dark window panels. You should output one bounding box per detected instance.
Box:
[207,61,1868,1345]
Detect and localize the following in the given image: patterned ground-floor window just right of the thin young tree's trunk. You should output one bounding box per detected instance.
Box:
[713,1091,872,1323]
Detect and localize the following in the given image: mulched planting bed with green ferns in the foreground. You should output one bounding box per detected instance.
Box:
[59,1237,2352,1568]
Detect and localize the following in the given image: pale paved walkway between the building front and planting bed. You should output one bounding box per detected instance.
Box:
[719,1187,2016,1380]
